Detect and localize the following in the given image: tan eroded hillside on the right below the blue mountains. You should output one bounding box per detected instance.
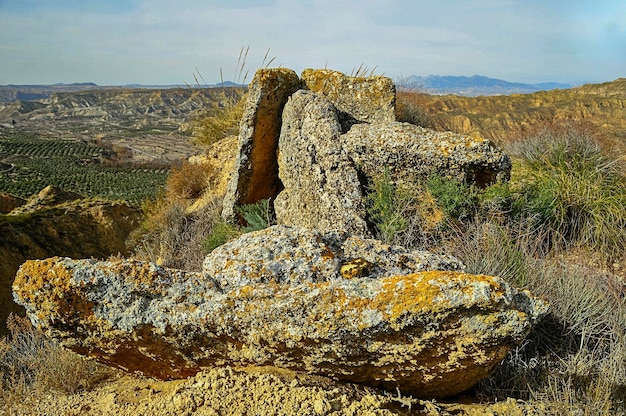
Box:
[399,78,626,150]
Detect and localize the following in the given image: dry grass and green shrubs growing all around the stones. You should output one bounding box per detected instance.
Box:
[0,89,626,415]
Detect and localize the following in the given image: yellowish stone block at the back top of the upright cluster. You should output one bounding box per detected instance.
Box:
[300,69,396,131]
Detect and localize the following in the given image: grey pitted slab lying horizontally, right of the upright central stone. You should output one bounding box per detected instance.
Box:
[342,122,511,186]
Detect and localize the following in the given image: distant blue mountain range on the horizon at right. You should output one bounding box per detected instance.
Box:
[396,75,574,97]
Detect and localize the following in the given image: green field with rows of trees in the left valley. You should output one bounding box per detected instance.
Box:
[0,132,168,203]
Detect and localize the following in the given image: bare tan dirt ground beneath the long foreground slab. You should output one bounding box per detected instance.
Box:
[0,367,542,416]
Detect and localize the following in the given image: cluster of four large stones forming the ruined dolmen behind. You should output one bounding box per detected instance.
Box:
[222,69,511,237]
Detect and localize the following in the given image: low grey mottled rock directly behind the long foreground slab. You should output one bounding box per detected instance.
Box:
[203,225,465,290]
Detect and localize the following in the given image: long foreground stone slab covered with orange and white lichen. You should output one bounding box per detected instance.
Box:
[13,252,546,397]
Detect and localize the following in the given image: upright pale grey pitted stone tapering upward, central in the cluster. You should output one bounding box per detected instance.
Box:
[274,90,370,236]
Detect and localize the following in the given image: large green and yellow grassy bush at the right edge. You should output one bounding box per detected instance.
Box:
[515,129,626,257]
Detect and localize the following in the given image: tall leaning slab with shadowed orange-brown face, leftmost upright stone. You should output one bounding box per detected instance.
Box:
[222,68,300,219]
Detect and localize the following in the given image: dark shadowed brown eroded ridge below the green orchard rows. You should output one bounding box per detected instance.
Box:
[0,197,141,333]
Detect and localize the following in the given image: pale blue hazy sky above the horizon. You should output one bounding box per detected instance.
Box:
[0,0,626,85]
